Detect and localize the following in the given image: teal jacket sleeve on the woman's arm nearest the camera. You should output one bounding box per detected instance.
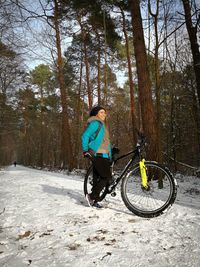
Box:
[81,121,98,152]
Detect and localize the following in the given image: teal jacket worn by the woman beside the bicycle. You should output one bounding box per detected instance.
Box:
[81,118,111,158]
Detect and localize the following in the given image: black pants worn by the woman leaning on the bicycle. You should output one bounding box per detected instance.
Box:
[90,157,112,201]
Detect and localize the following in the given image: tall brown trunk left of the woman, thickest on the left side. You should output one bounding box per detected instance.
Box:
[54,0,74,171]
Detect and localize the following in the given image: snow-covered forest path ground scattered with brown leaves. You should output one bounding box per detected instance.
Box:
[0,166,200,267]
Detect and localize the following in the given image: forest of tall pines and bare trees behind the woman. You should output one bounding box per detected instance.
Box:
[0,0,200,173]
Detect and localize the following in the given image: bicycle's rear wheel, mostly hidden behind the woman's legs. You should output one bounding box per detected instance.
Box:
[83,165,107,202]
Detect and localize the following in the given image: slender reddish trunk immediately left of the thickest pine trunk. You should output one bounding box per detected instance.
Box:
[120,7,138,144]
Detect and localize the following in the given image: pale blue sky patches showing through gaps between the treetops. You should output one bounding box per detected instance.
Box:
[11,0,199,87]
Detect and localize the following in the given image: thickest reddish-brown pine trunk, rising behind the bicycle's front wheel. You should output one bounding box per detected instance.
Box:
[129,0,158,160]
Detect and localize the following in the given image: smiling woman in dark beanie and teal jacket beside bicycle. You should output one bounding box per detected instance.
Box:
[82,106,112,208]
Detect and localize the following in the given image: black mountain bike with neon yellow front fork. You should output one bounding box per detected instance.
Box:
[84,134,177,218]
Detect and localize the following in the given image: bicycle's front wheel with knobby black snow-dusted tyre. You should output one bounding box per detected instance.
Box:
[121,161,177,218]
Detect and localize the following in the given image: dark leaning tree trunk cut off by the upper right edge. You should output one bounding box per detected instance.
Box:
[182,0,200,105]
